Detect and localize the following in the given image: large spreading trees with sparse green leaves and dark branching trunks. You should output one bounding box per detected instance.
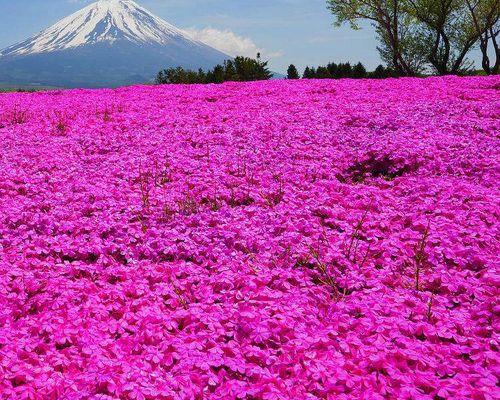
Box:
[327,0,500,76]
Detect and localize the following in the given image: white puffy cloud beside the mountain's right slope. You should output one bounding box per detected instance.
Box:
[184,27,282,58]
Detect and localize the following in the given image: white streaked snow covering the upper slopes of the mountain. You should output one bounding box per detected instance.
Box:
[1,0,205,56]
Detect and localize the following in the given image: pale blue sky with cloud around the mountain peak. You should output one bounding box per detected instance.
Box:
[0,0,484,72]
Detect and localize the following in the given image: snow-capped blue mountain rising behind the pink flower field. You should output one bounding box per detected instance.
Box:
[0,0,229,87]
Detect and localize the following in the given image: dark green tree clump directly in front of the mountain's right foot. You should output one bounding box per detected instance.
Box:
[156,54,272,84]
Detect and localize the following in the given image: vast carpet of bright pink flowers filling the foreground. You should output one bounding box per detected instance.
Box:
[0,77,500,400]
